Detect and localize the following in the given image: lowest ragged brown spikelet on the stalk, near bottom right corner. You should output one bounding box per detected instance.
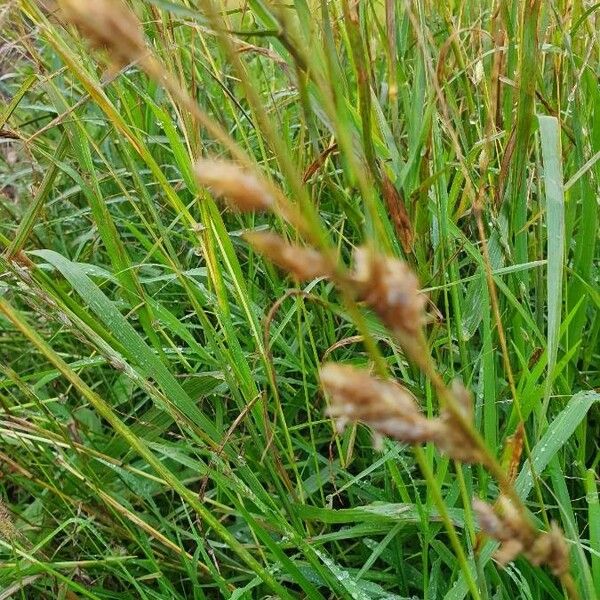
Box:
[473,496,569,577]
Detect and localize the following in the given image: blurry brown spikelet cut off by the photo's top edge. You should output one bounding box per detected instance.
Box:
[58,0,146,66]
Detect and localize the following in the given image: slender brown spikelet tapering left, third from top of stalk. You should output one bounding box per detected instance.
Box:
[244,231,333,281]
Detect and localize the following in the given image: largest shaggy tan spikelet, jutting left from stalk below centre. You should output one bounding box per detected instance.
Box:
[320,363,438,444]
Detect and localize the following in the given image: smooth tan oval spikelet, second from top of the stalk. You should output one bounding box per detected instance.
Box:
[194,158,275,212]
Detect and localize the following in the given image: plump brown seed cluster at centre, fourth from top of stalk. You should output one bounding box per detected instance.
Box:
[353,247,427,337]
